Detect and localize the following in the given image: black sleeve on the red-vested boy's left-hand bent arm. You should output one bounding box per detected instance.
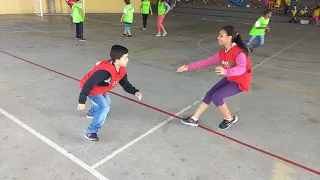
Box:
[79,70,111,104]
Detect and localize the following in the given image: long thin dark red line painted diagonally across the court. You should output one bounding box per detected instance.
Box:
[0,50,320,175]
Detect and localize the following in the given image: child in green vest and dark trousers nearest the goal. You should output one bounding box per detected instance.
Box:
[72,0,85,41]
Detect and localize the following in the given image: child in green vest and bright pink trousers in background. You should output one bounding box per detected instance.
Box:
[156,0,171,36]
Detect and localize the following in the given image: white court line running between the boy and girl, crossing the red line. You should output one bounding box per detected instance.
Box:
[91,101,200,169]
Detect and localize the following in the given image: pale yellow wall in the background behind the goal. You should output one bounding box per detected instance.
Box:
[0,0,151,14]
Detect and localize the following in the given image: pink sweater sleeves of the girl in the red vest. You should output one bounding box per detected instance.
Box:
[188,52,247,77]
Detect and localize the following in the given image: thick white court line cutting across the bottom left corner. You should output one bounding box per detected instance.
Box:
[0,108,109,180]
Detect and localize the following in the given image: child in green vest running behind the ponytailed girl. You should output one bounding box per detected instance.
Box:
[246,9,272,53]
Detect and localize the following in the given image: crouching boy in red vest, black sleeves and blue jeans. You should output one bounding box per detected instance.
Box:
[78,45,142,141]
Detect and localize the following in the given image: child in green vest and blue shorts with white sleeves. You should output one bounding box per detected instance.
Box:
[120,0,134,38]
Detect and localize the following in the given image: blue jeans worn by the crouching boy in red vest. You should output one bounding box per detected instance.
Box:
[87,94,111,133]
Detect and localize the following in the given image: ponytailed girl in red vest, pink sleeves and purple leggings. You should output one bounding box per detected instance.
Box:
[178,26,252,129]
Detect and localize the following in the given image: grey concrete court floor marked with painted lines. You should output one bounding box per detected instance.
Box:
[0,14,320,180]
